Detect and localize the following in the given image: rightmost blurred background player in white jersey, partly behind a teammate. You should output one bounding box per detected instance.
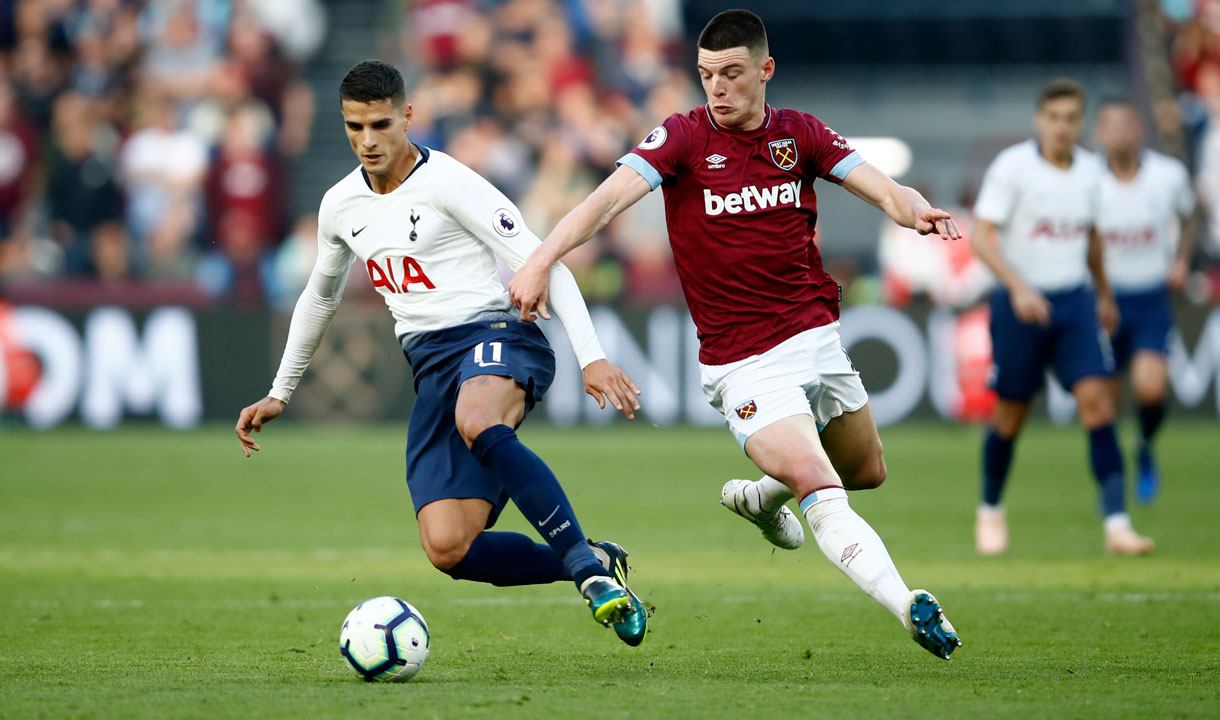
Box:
[1097,99,1194,503]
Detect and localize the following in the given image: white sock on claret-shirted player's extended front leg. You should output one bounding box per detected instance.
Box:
[800,488,910,620]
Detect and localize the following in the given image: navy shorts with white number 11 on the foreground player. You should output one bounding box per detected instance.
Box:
[403,321,555,527]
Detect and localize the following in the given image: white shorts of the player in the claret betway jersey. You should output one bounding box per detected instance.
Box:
[699,322,869,450]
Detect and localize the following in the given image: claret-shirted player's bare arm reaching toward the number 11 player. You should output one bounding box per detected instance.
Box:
[509,166,653,322]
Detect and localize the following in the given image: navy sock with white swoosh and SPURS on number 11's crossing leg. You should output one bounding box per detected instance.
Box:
[470,425,606,586]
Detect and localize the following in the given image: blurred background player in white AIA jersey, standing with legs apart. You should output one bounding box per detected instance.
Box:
[971,79,1153,555]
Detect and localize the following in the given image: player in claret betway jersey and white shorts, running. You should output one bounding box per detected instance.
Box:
[509,10,961,659]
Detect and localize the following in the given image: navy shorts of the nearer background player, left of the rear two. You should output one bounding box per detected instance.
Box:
[989,288,1114,400]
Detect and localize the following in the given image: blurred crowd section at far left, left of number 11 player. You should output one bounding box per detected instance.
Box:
[0,0,325,303]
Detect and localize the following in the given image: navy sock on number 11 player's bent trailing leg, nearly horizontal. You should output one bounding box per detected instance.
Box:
[445,531,572,587]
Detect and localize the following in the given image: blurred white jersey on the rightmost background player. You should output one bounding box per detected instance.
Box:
[1097,150,1194,292]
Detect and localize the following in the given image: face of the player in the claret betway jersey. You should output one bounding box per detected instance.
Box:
[698,48,775,129]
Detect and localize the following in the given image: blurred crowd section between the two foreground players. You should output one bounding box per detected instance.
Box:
[378,0,702,305]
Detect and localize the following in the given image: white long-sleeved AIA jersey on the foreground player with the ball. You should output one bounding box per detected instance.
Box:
[270,148,605,401]
